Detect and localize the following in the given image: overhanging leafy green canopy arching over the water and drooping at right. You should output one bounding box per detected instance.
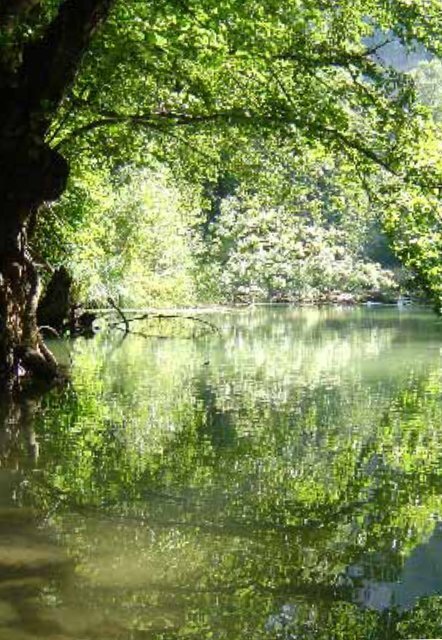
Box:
[8,0,442,306]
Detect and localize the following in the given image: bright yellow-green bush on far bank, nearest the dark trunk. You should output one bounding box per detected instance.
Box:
[35,167,199,306]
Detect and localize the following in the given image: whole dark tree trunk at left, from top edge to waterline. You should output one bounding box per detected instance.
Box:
[0,0,112,389]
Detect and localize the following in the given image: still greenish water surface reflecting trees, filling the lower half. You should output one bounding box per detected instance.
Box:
[0,307,442,640]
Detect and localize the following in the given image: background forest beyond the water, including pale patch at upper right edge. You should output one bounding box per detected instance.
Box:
[33,57,442,307]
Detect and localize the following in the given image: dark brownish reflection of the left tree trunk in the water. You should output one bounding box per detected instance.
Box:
[0,390,85,640]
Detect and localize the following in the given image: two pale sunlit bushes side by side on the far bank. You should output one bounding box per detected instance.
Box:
[37,153,400,306]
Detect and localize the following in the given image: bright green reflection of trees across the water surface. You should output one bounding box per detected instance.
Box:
[0,308,442,640]
